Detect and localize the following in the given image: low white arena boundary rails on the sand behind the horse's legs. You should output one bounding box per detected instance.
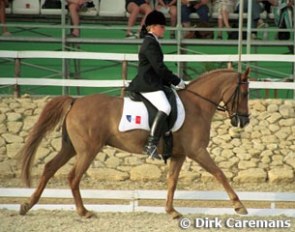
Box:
[0,188,295,217]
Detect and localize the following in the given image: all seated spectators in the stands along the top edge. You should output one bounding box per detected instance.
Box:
[0,0,294,39]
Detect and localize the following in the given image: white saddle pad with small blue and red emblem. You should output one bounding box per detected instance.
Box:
[119,94,185,132]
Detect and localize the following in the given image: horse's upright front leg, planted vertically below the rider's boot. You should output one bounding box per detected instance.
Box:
[166,156,185,219]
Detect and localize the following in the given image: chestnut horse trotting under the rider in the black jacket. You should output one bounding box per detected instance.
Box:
[20,69,249,218]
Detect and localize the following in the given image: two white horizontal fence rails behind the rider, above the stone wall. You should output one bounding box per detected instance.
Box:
[0,50,295,90]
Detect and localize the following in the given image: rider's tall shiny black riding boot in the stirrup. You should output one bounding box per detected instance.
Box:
[144,111,167,160]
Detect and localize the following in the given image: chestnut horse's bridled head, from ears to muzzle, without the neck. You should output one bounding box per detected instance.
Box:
[223,68,250,128]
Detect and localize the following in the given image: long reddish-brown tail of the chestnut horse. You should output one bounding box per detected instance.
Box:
[18,96,74,187]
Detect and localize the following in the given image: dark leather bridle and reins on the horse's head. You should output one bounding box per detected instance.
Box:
[185,73,249,119]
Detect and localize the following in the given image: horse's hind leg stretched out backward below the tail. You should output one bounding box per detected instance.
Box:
[20,142,75,215]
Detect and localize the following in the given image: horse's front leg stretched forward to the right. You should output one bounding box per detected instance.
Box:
[189,148,248,214]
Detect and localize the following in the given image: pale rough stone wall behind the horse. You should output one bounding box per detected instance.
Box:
[0,96,295,183]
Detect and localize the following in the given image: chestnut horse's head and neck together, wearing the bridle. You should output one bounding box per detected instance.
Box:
[185,68,250,128]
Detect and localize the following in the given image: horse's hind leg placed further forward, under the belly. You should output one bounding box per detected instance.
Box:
[68,147,97,218]
